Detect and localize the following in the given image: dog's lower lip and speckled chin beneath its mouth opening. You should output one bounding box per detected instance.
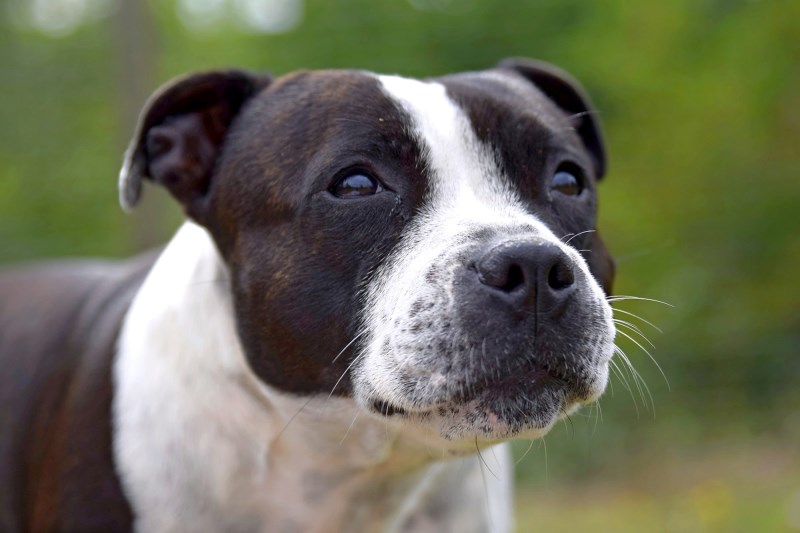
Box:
[356,369,607,451]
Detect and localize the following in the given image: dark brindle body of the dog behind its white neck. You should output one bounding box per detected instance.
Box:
[0,253,157,531]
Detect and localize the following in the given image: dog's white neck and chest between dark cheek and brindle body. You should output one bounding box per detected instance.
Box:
[114,223,508,531]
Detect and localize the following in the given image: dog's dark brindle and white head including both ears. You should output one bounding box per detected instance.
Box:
[122,61,614,444]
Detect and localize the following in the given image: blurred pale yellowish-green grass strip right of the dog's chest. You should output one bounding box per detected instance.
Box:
[517,445,800,533]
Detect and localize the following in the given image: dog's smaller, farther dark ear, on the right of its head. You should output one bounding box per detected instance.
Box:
[497,58,606,179]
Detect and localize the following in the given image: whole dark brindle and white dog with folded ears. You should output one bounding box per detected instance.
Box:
[0,59,615,532]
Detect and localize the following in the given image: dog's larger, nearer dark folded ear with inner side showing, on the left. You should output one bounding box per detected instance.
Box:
[119,70,269,219]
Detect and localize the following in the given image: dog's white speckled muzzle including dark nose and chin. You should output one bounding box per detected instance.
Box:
[355,227,614,440]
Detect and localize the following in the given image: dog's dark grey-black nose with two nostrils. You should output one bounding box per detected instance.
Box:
[475,241,575,312]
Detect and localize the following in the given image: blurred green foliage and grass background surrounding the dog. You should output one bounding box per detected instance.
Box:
[0,0,800,531]
